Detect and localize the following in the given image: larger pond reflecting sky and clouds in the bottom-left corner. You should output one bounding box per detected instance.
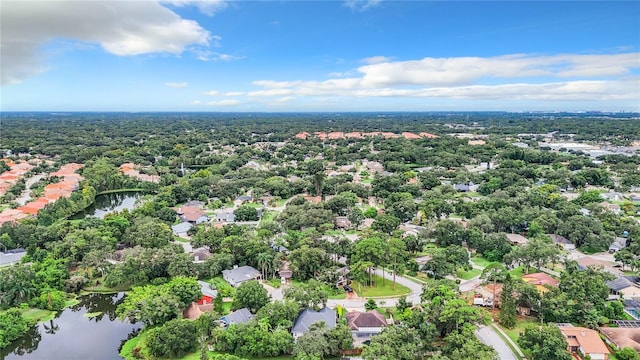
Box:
[0,293,142,360]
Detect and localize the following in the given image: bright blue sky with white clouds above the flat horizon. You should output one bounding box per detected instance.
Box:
[0,0,640,111]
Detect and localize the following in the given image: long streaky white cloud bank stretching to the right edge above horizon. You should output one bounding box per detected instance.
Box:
[241,53,640,101]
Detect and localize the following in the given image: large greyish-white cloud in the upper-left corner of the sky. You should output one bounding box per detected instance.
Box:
[0,0,216,85]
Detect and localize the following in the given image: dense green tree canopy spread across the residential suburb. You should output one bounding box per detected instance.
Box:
[0,113,640,359]
